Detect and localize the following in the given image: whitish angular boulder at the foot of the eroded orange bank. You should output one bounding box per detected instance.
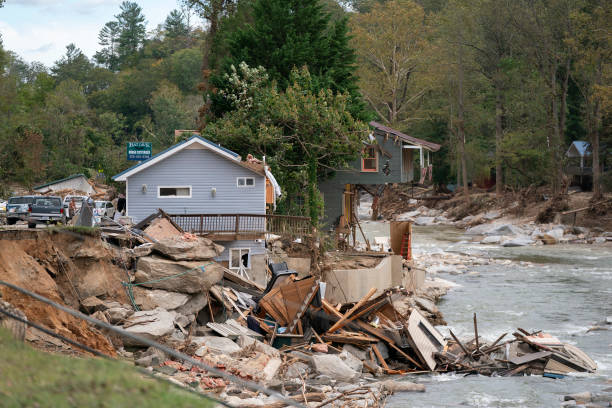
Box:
[123,309,176,345]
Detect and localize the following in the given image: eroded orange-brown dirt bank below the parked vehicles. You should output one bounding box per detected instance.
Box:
[0,230,128,355]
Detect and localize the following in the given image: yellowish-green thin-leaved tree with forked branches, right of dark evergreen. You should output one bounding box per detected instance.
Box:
[351,0,431,127]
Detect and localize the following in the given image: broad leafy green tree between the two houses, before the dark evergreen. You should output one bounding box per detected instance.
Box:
[204,64,368,225]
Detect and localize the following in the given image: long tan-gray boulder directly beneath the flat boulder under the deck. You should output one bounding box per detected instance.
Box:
[135,256,223,293]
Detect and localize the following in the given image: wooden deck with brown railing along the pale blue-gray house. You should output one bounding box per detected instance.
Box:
[168,214,312,241]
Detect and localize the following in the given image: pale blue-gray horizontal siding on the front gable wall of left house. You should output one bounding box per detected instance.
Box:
[126,148,266,222]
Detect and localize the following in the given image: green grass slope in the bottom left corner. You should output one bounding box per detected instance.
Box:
[0,328,213,408]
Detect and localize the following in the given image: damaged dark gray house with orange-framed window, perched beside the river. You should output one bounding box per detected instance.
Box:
[319,122,441,230]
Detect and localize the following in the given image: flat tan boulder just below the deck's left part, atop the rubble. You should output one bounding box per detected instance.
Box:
[153,235,223,261]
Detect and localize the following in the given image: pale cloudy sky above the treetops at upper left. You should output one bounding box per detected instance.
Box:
[0,0,178,67]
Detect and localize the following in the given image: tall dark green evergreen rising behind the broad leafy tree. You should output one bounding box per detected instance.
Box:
[213,0,363,115]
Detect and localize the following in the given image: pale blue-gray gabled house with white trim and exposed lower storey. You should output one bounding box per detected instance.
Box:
[113,135,304,283]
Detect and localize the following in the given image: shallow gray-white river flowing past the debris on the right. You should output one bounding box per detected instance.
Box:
[363,221,612,407]
